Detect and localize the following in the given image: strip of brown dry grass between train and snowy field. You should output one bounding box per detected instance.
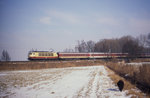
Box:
[0,60,104,71]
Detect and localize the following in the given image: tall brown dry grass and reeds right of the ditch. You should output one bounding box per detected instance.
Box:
[106,62,150,97]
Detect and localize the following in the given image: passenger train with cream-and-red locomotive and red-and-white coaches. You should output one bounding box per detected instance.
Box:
[28,51,128,60]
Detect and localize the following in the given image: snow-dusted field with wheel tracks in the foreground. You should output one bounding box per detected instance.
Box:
[0,66,131,98]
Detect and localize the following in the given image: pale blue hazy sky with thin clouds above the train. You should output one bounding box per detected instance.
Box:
[0,0,150,61]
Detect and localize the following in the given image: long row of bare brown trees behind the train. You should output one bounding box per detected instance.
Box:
[65,33,150,55]
